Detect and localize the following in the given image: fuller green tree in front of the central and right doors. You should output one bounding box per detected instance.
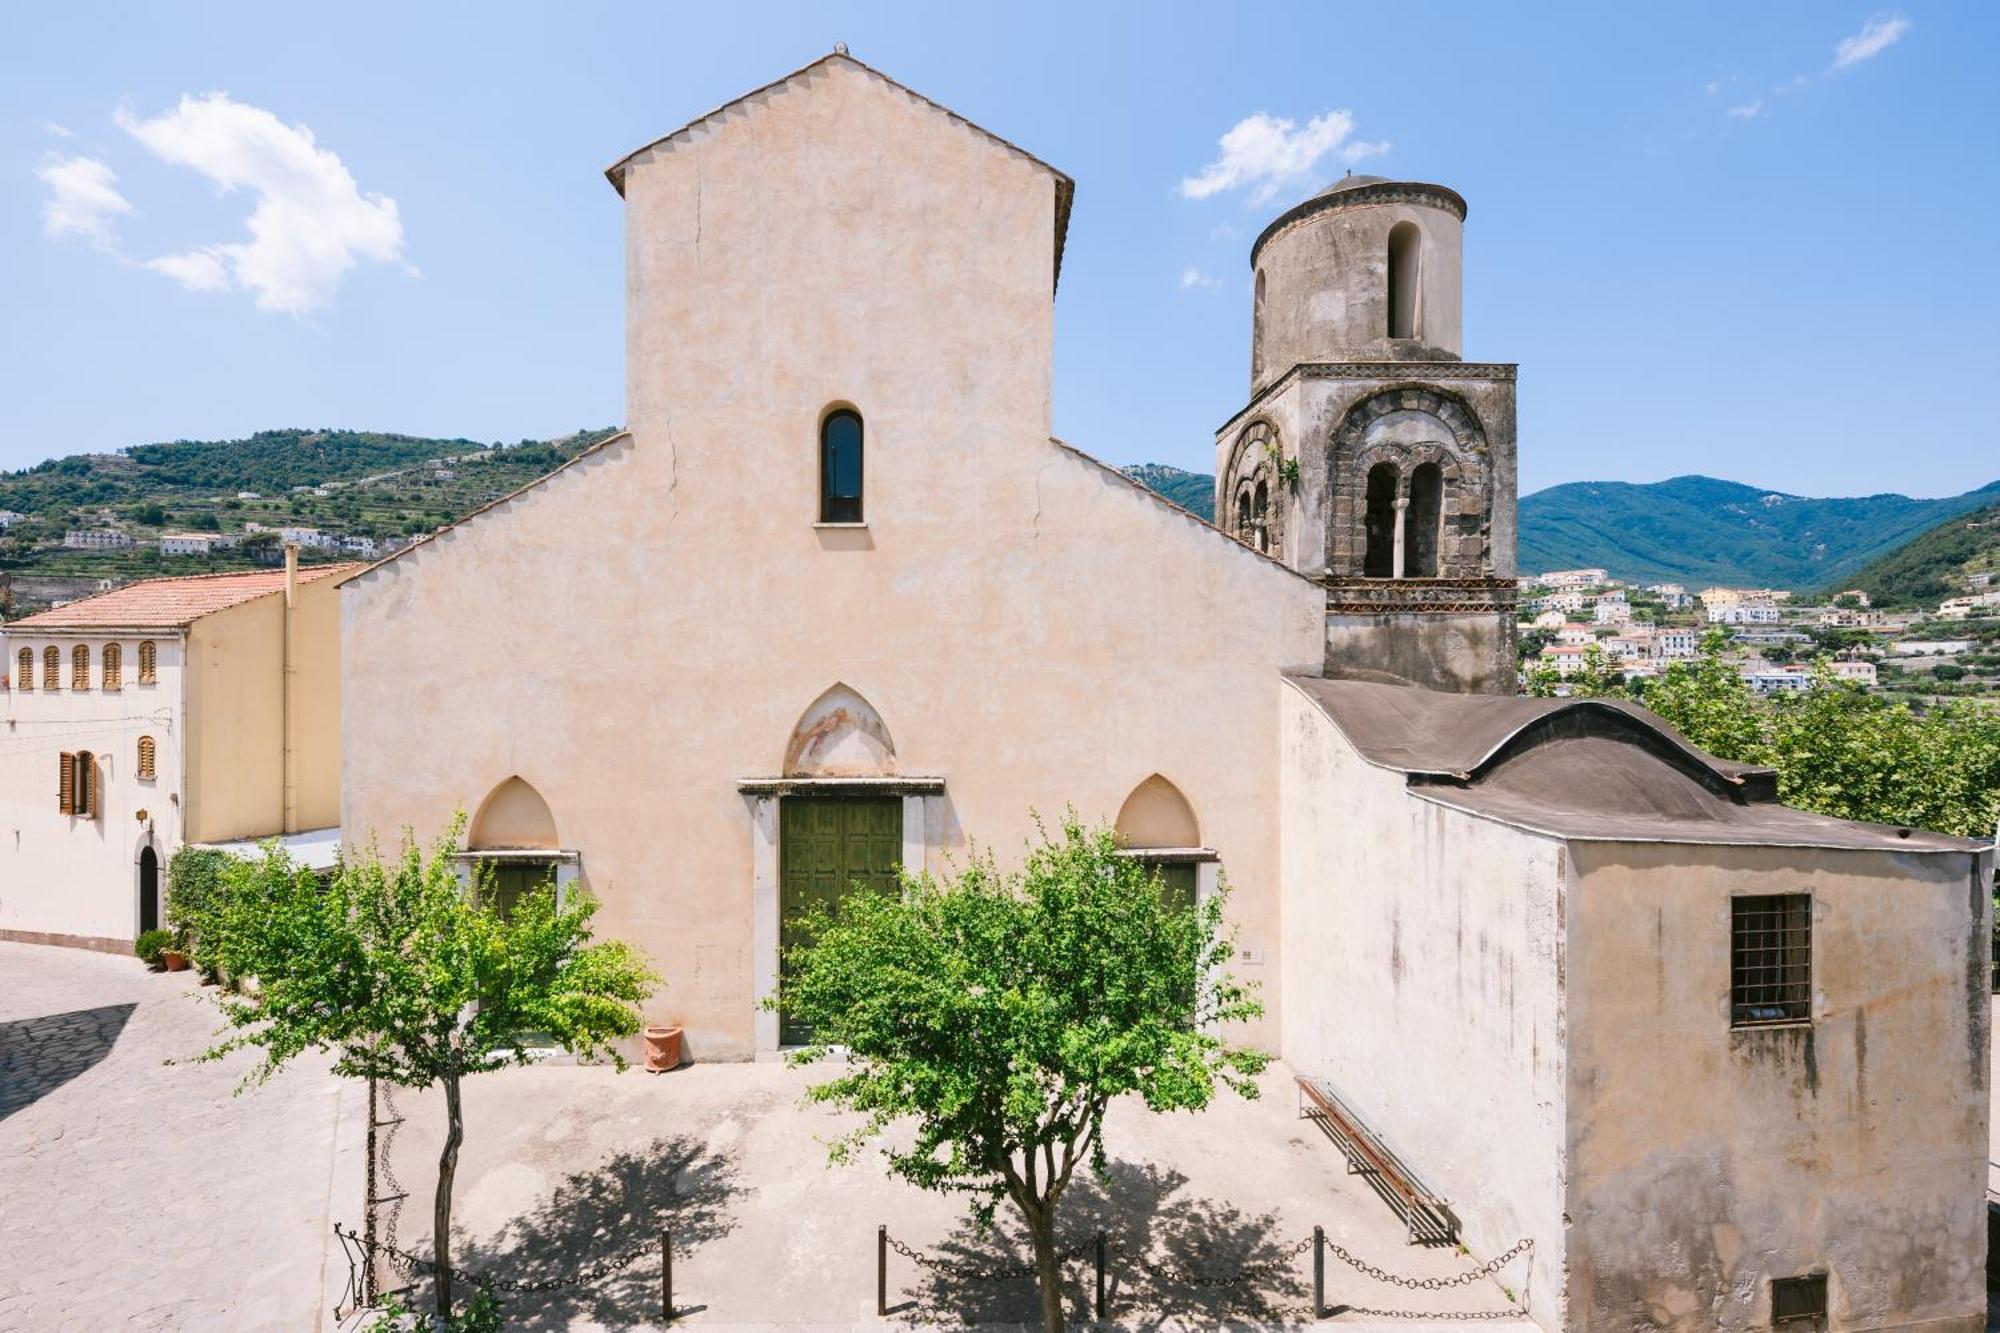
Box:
[766,815,1268,1333]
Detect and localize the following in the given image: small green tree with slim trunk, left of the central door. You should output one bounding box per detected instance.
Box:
[202,815,658,1319]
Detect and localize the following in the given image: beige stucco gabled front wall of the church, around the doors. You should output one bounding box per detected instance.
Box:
[342,64,1322,1059]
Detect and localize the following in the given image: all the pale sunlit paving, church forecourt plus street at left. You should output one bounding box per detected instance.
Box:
[0,945,1532,1331]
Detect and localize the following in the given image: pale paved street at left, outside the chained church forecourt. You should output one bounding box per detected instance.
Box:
[0,943,364,1333]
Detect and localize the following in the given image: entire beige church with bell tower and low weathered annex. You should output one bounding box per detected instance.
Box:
[340,52,1990,1331]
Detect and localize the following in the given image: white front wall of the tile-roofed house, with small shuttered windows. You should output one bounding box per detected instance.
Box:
[0,630,184,943]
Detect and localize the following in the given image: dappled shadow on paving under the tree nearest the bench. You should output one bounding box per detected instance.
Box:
[890,1161,1312,1327]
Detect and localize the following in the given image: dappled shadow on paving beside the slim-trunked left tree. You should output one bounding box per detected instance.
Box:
[452,1135,744,1329]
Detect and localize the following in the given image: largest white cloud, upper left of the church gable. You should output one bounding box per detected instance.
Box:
[118,92,402,314]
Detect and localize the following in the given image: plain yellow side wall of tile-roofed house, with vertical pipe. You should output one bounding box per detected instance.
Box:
[188,578,340,843]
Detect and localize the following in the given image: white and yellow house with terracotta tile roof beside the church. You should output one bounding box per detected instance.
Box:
[0,552,360,951]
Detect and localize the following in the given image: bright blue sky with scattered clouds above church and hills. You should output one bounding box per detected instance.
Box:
[0,2,2000,494]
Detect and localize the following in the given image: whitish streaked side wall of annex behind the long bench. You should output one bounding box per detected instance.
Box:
[1278,685,1566,1329]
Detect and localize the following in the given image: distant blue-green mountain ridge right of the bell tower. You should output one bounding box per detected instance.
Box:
[1520,476,2000,588]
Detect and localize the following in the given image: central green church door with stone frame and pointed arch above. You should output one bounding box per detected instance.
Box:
[736,681,948,1059]
